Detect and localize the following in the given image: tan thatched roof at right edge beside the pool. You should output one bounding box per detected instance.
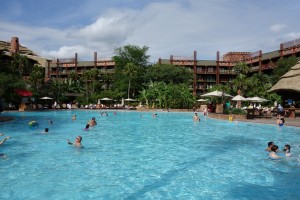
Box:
[269,62,300,93]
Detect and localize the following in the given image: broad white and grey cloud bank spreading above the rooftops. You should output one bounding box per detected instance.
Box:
[0,0,300,61]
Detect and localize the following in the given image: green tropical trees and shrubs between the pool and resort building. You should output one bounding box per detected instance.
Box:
[0,45,298,109]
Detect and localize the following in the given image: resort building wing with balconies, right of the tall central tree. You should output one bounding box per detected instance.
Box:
[158,38,300,94]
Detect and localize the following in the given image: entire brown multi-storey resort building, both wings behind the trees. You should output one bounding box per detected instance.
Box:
[0,37,300,95]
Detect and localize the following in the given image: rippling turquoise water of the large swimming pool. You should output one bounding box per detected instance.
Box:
[0,110,300,199]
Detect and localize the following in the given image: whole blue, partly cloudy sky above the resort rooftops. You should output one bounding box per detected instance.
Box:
[0,0,300,62]
